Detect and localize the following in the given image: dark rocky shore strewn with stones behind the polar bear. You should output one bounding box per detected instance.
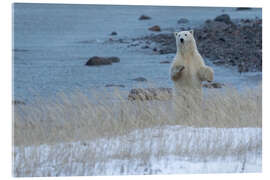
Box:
[136,14,262,72]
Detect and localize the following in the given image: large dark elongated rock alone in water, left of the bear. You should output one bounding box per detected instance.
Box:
[85,56,120,66]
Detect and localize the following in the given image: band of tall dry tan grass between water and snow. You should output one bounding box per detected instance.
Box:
[13,86,262,146]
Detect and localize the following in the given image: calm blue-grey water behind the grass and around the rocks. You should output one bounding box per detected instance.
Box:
[13,4,262,101]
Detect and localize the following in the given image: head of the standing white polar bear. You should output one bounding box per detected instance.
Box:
[174,30,197,53]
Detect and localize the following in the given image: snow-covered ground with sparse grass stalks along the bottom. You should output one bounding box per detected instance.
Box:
[13,126,262,176]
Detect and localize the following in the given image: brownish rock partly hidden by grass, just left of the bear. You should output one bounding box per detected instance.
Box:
[128,88,172,101]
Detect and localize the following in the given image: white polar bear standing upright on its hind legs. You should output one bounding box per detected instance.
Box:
[170,30,214,100]
